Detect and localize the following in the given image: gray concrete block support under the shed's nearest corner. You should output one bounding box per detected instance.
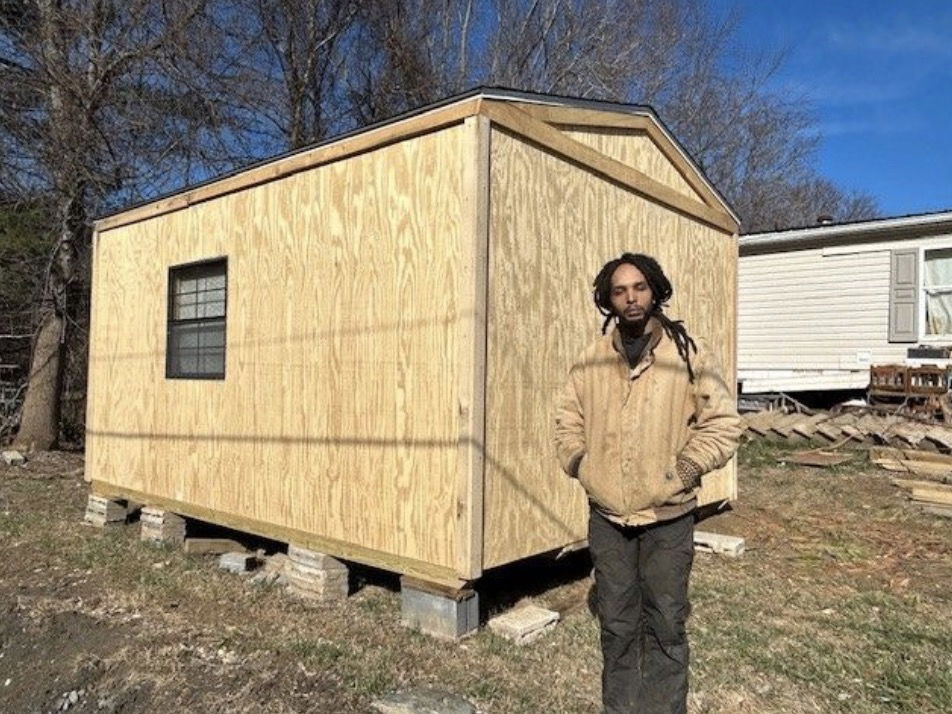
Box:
[400,577,479,641]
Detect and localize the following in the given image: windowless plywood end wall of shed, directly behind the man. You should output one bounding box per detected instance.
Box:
[484,126,737,567]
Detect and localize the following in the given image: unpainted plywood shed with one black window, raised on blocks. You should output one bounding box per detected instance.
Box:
[86,89,737,587]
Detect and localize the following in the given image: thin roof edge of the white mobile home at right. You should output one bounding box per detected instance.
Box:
[737,211,952,255]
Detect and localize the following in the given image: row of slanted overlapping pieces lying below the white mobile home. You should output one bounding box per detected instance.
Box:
[741,409,952,453]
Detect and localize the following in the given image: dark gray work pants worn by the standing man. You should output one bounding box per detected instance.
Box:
[588,508,694,714]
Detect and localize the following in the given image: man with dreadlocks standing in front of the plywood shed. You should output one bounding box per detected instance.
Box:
[555,253,741,714]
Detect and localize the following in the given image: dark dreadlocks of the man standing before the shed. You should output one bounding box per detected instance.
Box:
[592,253,697,382]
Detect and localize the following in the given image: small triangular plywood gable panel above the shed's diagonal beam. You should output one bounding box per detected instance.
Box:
[559,126,704,202]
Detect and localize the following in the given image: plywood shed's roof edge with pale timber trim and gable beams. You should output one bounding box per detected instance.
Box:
[95,87,740,233]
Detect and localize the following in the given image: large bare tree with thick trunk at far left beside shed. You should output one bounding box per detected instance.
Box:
[0,0,231,448]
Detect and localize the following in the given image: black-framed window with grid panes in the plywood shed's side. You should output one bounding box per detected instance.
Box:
[165,258,228,379]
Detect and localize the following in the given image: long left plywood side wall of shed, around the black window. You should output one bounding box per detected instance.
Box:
[87,125,474,572]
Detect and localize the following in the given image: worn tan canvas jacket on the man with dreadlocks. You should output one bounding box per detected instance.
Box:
[555,319,741,525]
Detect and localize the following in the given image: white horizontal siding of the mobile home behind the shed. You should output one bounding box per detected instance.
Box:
[737,228,952,394]
